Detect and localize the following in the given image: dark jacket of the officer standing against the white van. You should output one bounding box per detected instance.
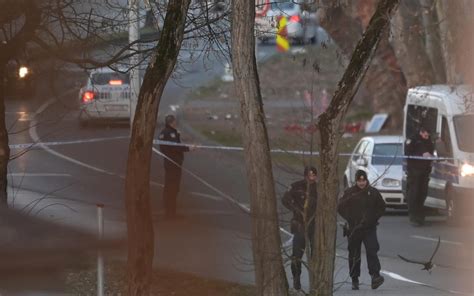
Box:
[405,135,434,174]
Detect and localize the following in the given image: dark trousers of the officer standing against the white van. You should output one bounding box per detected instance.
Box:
[407,169,430,223]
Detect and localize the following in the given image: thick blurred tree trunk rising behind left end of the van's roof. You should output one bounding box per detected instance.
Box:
[391,0,435,87]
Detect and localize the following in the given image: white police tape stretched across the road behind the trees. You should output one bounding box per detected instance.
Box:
[9,136,454,161]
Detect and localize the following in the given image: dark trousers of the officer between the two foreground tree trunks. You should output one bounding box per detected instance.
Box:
[291,220,314,277]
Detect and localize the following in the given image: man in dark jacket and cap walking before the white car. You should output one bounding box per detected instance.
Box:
[337,170,385,290]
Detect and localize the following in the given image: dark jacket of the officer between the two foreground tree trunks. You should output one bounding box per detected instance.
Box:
[282,180,318,224]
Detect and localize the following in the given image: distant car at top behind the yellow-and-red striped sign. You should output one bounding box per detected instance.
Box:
[255,0,317,43]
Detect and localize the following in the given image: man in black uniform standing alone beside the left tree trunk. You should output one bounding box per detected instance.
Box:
[159,114,194,218]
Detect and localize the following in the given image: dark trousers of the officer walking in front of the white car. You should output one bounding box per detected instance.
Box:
[348,227,380,278]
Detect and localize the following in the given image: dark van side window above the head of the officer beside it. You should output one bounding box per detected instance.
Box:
[405,105,438,139]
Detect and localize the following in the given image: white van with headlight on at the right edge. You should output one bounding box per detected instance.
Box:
[402,85,474,220]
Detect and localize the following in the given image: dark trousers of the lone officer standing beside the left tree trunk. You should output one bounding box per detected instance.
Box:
[163,164,181,215]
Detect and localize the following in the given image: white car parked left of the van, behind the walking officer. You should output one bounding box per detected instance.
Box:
[344,136,407,208]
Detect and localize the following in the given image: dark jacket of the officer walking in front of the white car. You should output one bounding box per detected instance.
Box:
[337,185,385,230]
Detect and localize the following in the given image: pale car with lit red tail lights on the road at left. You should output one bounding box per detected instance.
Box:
[79,68,130,125]
